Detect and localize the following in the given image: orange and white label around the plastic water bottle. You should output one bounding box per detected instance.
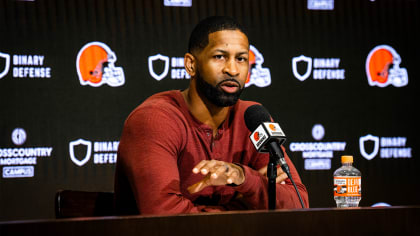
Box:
[334,176,362,197]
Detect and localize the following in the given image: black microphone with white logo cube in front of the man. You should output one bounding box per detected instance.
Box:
[244,105,291,172]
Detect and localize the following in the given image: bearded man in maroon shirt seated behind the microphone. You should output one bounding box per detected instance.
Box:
[115,17,308,214]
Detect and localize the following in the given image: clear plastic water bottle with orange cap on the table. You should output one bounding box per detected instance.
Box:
[334,156,362,208]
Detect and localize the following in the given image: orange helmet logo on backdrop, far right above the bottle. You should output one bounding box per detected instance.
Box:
[366,45,408,87]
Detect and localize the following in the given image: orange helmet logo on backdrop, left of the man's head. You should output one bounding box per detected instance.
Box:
[76,42,125,87]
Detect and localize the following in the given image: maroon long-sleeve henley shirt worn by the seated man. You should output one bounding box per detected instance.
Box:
[115,90,308,214]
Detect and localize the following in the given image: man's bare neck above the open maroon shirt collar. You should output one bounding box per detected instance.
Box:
[182,88,229,136]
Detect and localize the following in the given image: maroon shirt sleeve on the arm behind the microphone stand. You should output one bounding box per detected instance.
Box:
[230,146,309,209]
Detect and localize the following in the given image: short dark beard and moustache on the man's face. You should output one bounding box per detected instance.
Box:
[196,71,244,107]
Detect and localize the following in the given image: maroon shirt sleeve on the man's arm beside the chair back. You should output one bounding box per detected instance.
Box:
[118,109,224,214]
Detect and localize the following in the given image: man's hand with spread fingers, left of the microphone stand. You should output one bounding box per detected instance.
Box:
[188,160,245,193]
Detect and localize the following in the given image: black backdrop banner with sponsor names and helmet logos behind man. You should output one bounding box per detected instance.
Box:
[0,0,420,220]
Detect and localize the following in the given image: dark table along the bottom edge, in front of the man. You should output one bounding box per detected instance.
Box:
[0,206,420,236]
